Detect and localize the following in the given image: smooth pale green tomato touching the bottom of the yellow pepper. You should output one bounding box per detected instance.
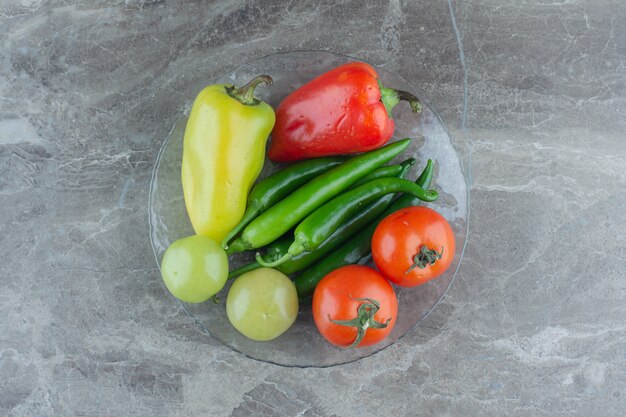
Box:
[161,235,228,303]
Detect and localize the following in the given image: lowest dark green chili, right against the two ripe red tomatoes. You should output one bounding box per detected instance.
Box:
[294,160,433,300]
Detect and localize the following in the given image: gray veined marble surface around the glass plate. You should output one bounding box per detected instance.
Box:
[0,0,626,417]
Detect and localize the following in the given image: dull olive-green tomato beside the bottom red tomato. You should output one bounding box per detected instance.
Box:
[226,268,298,341]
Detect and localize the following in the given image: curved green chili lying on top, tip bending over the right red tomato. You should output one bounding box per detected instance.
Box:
[256,178,438,267]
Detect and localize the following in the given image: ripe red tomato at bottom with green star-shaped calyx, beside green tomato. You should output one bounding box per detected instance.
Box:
[313,265,398,347]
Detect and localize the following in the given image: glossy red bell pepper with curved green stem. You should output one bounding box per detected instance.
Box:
[269,62,421,162]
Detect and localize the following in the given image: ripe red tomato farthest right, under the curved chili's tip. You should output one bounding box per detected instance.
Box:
[372,206,455,287]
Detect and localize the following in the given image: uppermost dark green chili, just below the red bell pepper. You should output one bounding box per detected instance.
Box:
[222,156,346,249]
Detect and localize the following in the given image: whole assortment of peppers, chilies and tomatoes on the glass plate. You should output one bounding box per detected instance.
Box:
[161,62,455,348]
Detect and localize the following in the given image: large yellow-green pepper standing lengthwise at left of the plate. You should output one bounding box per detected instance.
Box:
[182,75,275,242]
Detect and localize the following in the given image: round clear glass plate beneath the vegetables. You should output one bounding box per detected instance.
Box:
[149,51,468,367]
